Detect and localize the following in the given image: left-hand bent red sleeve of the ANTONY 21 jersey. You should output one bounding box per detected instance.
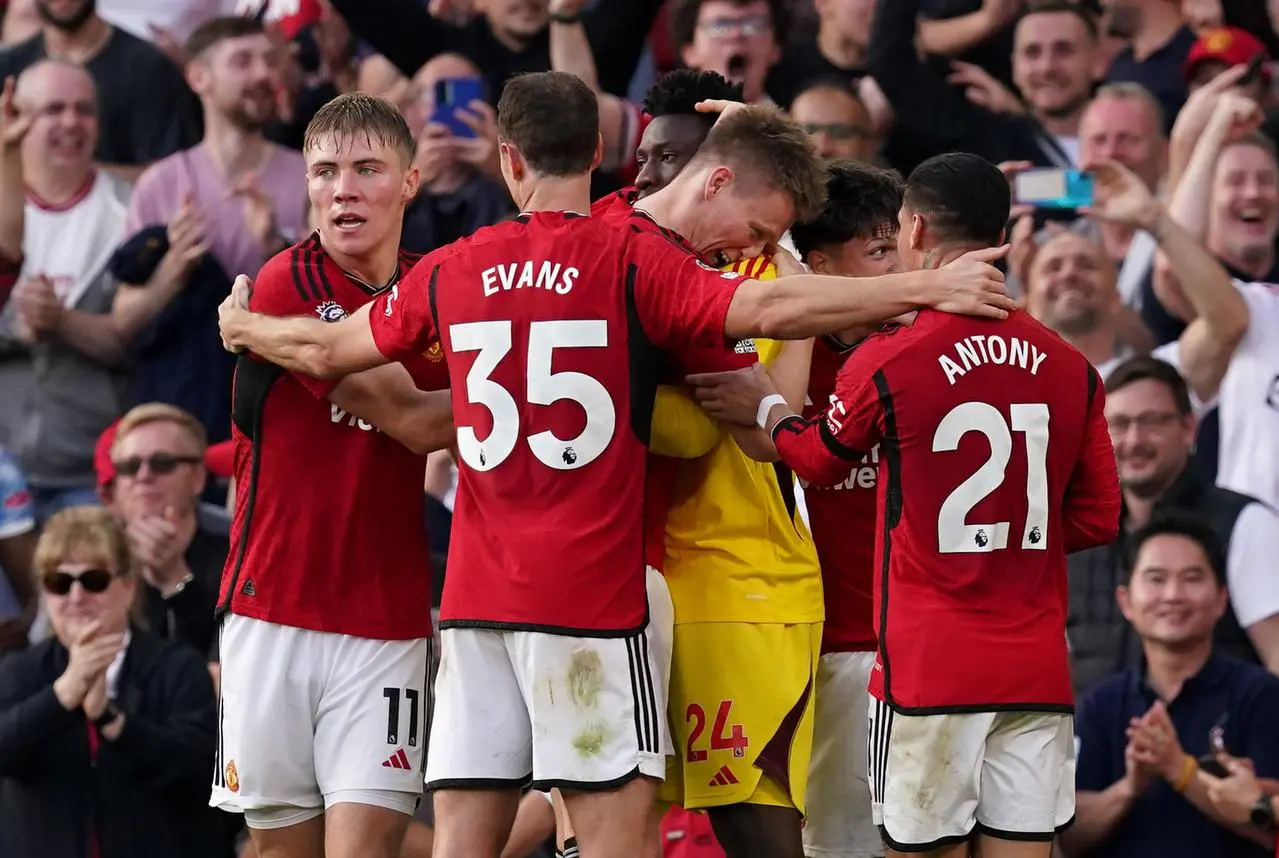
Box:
[773,327,911,486]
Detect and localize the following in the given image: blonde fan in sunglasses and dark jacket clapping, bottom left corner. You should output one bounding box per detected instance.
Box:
[0,506,217,858]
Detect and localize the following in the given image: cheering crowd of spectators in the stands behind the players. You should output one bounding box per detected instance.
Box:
[0,0,1279,858]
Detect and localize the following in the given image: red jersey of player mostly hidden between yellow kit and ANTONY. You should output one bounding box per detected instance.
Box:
[799,336,879,653]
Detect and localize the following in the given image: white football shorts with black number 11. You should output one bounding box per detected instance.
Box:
[210,614,432,829]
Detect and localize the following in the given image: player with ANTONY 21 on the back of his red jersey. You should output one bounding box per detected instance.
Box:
[690,155,1119,858]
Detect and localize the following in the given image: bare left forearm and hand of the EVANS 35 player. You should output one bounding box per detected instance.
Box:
[217,274,390,378]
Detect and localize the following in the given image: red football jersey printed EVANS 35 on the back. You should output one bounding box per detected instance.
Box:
[371,212,741,636]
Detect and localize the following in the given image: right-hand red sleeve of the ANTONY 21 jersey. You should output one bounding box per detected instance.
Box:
[1062,367,1123,554]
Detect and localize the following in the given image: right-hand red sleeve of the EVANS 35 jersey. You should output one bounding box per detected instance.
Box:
[627,231,746,372]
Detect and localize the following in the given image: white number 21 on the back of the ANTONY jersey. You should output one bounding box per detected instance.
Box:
[932,402,1049,554]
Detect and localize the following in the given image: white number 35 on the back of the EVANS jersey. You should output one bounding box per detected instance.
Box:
[449,318,618,471]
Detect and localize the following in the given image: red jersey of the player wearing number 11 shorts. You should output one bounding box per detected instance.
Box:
[219,234,449,641]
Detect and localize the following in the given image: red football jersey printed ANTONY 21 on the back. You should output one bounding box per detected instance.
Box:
[774,311,1119,715]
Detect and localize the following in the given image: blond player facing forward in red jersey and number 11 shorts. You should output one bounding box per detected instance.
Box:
[204,95,451,858]
